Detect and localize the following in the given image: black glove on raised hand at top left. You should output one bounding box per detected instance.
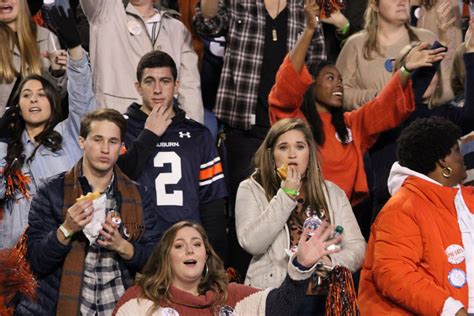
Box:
[43,6,81,48]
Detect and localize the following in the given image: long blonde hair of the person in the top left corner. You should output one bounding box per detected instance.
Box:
[0,0,42,83]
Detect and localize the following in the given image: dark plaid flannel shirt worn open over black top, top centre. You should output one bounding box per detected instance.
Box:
[194,0,326,130]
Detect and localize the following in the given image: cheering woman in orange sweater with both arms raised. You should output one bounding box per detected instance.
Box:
[268,0,445,235]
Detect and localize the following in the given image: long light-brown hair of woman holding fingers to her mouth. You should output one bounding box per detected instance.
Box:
[254,118,330,221]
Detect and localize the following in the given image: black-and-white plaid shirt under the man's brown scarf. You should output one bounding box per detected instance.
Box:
[80,178,125,315]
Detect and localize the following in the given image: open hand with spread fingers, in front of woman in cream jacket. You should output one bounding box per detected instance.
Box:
[296,222,342,267]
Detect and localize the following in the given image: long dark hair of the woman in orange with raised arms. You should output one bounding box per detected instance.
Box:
[301,61,349,146]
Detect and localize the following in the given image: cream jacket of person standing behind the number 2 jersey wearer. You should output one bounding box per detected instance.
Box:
[80,0,204,123]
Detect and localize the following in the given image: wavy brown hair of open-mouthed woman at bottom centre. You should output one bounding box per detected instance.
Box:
[137,221,228,314]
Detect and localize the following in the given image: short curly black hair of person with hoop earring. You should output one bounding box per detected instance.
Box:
[397,117,462,175]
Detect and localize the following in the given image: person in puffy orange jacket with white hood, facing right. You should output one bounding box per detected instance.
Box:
[359,117,474,316]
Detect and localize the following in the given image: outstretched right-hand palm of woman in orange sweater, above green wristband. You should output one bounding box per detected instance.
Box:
[404,43,446,71]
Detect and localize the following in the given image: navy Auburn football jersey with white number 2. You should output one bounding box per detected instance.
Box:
[125,104,227,226]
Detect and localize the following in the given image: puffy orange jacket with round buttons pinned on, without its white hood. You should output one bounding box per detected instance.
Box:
[359,176,474,316]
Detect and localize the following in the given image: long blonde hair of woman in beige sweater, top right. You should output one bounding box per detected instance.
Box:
[364,0,420,60]
